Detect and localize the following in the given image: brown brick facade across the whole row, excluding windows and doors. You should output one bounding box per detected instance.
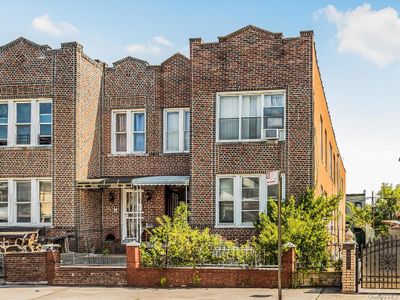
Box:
[0,26,345,251]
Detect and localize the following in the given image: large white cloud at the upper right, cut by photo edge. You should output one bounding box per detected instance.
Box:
[314,4,400,67]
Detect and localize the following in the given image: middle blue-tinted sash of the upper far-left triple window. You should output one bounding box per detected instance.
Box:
[15,103,31,145]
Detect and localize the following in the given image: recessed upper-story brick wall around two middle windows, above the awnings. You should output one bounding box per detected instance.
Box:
[102,55,191,176]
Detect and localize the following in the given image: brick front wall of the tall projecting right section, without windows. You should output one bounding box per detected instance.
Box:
[190,26,313,236]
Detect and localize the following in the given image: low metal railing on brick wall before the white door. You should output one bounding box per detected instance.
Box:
[60,252,126,266]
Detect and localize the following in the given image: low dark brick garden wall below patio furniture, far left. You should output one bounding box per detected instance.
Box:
[4,252,47,283]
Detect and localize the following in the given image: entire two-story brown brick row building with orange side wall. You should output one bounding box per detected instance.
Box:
[0,26,346,250]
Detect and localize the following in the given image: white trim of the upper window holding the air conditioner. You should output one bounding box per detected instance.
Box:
[215,90,287,143]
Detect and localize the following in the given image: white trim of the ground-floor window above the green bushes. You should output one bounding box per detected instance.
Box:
[215,174,268,228]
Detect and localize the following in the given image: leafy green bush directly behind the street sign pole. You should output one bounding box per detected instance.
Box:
[253,189,341,271]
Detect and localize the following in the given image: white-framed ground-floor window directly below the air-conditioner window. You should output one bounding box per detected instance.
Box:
[216,175,268,227]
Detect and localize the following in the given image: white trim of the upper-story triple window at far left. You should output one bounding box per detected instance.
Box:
[0,98,54,149]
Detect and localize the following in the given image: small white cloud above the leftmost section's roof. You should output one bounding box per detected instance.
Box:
[32,14,79,37]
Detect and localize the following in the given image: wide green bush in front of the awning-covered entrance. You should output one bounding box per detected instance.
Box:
[140,203,247,267]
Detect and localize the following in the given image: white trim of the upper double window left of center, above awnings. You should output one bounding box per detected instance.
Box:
[111,109,147,155]
